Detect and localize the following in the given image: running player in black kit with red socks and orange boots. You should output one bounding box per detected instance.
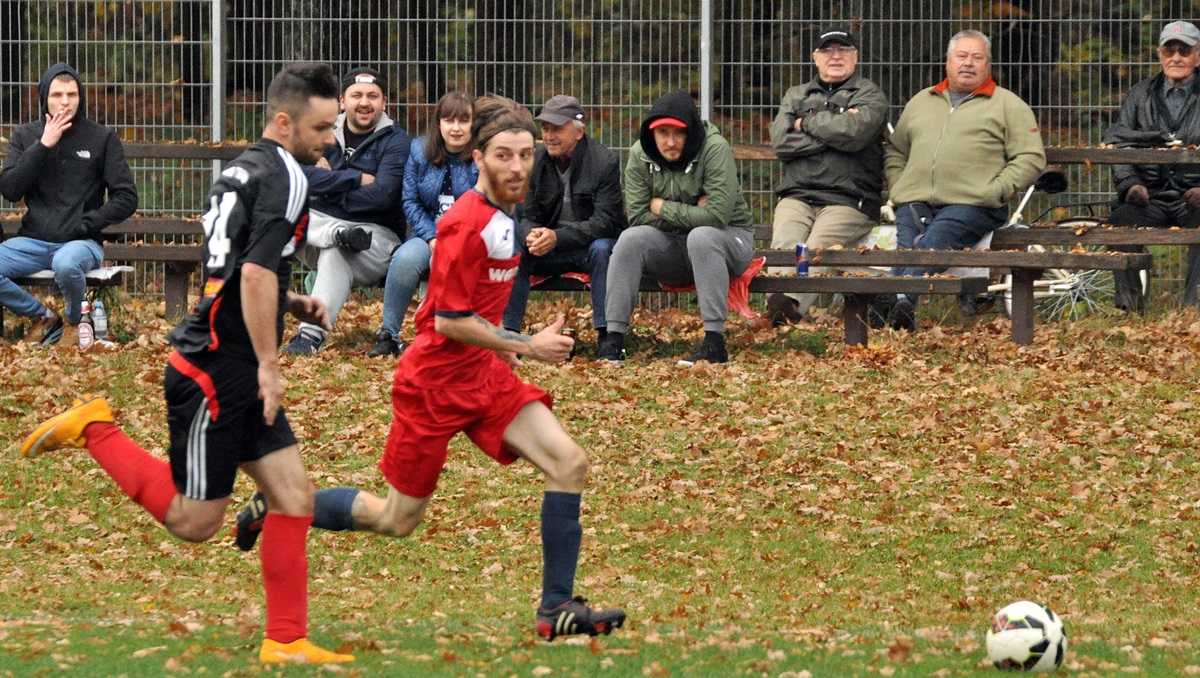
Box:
[22,64,354,662]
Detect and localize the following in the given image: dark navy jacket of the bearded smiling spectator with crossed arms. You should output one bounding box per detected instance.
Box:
[305,113,409,240]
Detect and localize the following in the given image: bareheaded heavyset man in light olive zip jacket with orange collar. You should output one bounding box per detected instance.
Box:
[872,30,1046,330]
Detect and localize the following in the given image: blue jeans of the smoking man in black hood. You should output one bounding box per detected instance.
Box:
[0,236,104,325]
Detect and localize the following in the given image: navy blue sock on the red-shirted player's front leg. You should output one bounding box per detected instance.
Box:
[541,491,583,610]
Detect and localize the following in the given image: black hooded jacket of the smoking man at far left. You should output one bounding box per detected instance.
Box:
[0,62,138,242]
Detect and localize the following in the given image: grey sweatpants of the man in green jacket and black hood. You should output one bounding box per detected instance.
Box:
[605,226,754,332]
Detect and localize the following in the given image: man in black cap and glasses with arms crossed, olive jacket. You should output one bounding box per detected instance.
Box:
[767,29,888,325]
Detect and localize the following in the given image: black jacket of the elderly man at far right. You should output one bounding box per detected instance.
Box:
[1104,73,1200,202]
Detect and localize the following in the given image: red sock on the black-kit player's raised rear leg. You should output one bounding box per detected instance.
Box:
[85,422,179,522]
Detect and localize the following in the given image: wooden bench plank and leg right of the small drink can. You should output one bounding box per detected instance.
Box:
[812,250,1153,346]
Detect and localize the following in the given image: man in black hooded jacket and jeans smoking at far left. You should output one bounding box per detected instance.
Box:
[0,62,138,347]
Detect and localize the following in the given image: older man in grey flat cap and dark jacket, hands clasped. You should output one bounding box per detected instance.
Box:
[504,95,628,336]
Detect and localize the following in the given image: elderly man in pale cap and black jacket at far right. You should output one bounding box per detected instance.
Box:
[1104,22,1200,312]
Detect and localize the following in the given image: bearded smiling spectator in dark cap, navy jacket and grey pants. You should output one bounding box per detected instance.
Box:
[283,67,409,354]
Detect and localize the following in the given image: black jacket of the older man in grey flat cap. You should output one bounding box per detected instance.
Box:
[518,136,629,250]
